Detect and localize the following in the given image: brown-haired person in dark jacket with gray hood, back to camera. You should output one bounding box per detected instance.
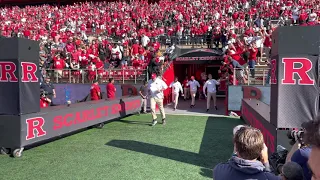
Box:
[213,126,281,180]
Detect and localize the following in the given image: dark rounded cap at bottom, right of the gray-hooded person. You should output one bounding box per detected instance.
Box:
[281,162,305,180]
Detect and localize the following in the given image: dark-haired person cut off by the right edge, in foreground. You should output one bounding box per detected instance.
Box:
[302,117,320,180]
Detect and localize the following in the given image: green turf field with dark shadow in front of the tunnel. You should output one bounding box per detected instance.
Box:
[0,114,242,180]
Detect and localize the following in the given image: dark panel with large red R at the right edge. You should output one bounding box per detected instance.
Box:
[271,54,319,128]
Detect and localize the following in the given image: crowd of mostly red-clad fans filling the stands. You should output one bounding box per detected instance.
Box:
[0,0,320,83]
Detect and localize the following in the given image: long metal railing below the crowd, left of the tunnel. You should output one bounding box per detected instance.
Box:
[42,67,147,84]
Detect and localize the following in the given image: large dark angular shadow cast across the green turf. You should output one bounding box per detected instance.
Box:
[106,117,242,178]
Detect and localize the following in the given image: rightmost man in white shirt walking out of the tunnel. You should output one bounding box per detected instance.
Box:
[203,74,220,112]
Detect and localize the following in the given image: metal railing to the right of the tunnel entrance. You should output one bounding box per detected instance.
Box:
[229,68,271,86]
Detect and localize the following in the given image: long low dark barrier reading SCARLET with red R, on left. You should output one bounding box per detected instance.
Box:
[0,96,141,148]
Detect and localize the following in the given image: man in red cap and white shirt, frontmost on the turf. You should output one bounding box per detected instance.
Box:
[148,73,168,126]
